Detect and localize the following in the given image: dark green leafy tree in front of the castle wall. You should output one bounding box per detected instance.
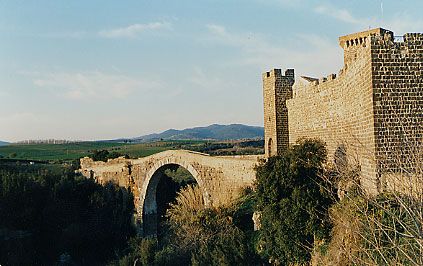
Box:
[256,140,332,264]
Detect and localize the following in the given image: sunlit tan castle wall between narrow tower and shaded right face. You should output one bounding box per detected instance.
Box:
[287,38,379,193]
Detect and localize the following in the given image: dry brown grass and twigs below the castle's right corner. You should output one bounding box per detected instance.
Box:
[312,147,423,265]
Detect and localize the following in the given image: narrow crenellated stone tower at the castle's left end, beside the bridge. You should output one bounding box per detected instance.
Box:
[263,69,295,158]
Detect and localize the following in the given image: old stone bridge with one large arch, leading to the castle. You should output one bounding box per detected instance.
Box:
[79,150,263,233]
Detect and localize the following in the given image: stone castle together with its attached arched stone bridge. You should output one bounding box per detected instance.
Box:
[79,29,423,235]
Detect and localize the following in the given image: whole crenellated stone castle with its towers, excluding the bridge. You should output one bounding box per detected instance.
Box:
[263,28,423,193]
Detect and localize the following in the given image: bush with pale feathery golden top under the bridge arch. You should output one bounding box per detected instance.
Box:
[167,187,255,265]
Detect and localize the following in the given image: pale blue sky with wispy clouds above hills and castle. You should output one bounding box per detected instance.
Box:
[0,0,423,142]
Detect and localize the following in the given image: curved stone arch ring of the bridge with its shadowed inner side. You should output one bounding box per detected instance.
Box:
[139,158,211,235]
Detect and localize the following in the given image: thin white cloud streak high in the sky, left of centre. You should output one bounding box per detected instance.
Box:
[98,22,171,38]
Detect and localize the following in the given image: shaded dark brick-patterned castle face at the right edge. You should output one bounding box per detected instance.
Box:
[371,33,423,187]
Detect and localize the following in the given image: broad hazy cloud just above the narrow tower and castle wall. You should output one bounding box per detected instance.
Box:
[206,24,342,76]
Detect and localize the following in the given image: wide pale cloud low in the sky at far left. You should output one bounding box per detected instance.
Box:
[33,71,159,100]
